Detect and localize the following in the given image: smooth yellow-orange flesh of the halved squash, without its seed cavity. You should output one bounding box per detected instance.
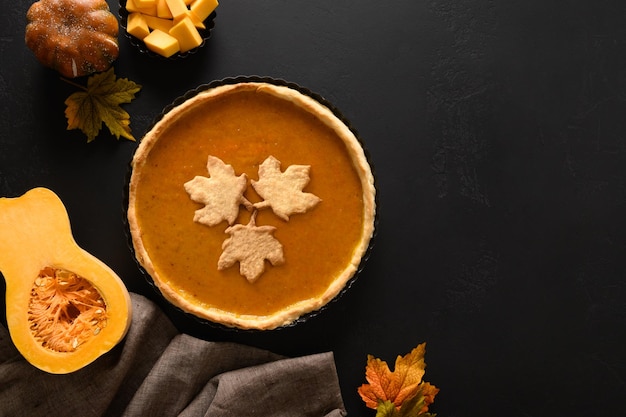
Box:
[0,188,132,374]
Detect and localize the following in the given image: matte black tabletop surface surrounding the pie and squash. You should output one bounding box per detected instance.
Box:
[0,0,626,416]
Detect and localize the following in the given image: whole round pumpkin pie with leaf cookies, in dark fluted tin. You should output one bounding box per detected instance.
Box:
[127,78,376,330]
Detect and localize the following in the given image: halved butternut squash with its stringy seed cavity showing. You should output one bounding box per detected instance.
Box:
[0,188,132,374]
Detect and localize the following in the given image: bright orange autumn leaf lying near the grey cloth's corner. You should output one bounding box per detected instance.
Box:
[358,343,439,412]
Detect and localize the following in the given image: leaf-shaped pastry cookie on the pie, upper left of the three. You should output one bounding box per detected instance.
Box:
[184,155,252,226]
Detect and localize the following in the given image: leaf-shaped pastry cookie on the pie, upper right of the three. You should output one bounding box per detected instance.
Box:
[251,156,322,221]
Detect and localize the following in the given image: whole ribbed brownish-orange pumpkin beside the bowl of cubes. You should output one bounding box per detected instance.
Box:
[25,0,119,78]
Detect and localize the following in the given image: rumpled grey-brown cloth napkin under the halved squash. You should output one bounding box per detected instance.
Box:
[0,294,347,417]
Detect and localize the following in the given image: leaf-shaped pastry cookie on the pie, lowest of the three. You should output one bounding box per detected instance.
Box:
[217,211,285,283]
